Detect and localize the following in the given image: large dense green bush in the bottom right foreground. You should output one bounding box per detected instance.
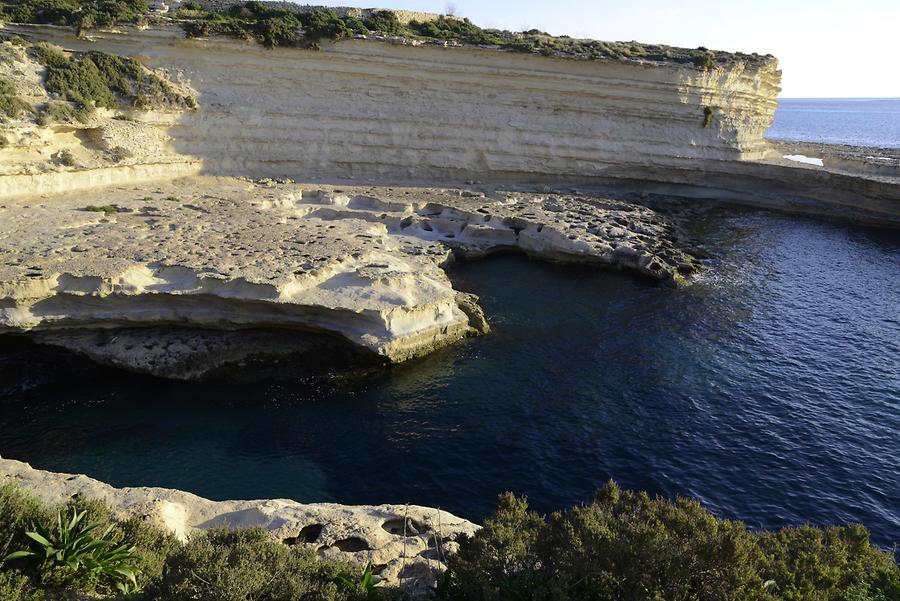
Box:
[439,483,900,601]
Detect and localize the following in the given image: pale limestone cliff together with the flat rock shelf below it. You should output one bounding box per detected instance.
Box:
[0,14,900,378]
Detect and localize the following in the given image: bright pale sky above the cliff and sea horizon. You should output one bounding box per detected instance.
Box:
[304,0,900,98]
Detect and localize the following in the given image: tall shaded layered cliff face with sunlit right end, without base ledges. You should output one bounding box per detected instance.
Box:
[1,27,780,182]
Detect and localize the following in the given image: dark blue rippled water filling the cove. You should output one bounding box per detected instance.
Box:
[0,210,900,544]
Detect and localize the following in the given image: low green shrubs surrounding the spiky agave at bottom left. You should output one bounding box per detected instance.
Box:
[0,482,399,601]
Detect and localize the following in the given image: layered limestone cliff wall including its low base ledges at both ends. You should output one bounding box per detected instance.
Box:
[0,24,900,226]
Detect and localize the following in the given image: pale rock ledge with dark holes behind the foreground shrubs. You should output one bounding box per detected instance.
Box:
[0,458,478,595]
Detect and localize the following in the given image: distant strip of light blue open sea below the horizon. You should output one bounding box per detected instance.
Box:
[766,98,900,148]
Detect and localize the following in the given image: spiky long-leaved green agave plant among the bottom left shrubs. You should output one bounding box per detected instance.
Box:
[3,508,138,594]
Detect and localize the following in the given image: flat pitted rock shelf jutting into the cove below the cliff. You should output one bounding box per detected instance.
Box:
[0,178,698,378]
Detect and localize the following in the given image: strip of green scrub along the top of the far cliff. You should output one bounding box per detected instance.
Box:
[0,0,773,70]
